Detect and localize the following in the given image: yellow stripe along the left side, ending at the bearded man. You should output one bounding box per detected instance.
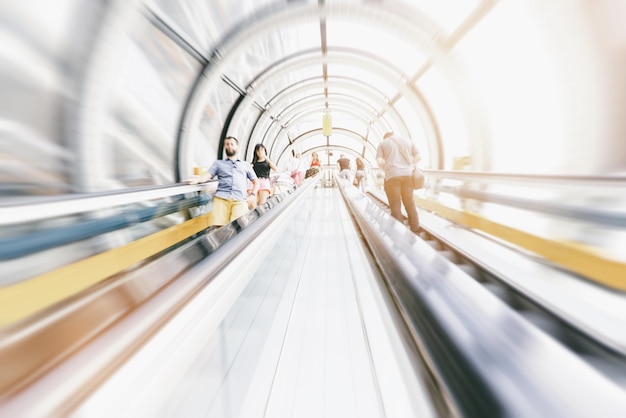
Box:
[0,213,210,327]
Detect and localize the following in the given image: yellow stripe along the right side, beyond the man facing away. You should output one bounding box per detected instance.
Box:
[415,197,626,290]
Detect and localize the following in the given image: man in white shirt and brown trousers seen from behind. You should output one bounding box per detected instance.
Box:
[376,132,421,232]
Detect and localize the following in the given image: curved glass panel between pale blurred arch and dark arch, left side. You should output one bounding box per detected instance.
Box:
[103,20,201,186]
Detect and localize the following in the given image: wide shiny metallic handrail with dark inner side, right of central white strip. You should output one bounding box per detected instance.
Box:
[340,177,626,417]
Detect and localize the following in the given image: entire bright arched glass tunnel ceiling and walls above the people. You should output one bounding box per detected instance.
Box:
[0,0,626,195]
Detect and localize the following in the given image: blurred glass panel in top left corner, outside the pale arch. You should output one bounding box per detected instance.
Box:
[0,0,102,199]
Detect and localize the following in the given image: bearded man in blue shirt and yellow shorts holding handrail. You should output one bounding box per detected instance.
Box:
[186,136,259,226]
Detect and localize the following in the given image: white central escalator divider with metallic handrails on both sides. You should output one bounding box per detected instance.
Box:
[0,171,624,417]
